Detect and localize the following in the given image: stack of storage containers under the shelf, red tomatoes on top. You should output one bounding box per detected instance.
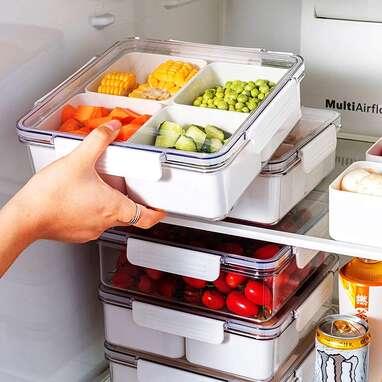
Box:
[99,224,337,381]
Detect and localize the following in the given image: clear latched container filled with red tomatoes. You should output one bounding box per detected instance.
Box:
[99,224,325,322]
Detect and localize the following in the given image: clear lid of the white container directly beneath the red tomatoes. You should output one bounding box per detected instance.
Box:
[99,255,338,340]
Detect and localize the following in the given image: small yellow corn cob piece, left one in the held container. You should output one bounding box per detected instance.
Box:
[98,72,137,96]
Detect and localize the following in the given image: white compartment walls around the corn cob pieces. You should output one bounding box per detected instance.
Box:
[86,52,207,103]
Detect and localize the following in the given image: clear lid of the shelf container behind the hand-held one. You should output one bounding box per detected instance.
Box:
[262,107,340,174]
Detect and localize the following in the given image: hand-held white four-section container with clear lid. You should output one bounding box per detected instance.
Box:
[18,38,304,219]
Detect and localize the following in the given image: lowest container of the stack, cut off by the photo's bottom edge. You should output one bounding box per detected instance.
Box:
[105,340,315,382]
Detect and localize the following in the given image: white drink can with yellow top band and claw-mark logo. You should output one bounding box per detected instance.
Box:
[314,314,370,382]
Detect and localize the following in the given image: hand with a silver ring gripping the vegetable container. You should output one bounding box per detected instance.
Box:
[11,121,165,243]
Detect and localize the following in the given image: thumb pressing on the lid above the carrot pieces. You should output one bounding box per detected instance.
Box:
[75,120,122,165]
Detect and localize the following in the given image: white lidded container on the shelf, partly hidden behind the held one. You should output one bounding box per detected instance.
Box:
[229,107,340,224]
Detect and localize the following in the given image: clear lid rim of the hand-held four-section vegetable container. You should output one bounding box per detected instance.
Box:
[18,38,303,170]
